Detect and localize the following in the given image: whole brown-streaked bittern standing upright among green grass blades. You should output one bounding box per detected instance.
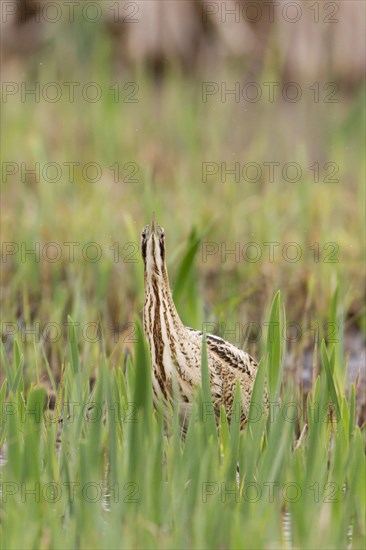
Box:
[141,218,257,424]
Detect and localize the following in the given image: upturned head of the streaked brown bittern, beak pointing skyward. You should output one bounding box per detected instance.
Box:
[141,213,165,275]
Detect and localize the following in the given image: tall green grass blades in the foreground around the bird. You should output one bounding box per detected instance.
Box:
[0,294,366,549]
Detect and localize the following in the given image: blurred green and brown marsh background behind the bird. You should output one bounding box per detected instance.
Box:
[1,0,365,410]
